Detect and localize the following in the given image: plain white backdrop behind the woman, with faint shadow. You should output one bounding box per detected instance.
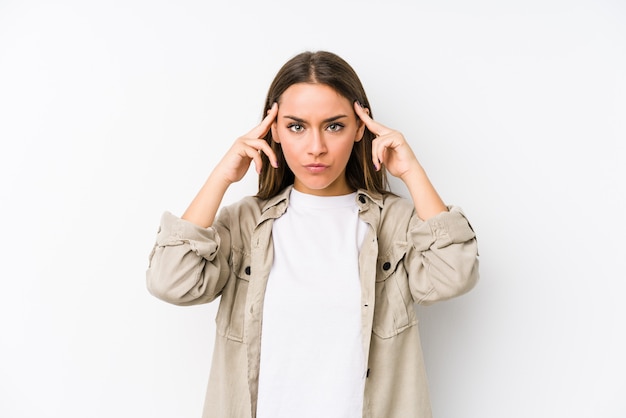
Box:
[0,0,626,418]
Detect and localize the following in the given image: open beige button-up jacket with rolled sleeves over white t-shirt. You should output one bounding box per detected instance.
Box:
[147,188,478,418]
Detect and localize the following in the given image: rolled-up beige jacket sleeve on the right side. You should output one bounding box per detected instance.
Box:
[406,206,479,304]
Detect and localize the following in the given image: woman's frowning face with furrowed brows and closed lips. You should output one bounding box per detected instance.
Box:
[272,83,365,196]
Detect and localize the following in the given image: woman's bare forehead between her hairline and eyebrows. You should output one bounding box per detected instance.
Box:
[278,83,352,114]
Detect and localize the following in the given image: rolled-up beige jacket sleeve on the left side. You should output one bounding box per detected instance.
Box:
[146,212,229,305]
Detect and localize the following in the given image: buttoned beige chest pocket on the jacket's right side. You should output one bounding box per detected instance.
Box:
[372,243,417,338]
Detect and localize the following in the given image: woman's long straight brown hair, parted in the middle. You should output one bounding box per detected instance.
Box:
[257,51,388,199]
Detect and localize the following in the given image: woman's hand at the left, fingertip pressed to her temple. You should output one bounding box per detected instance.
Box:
[213,103,278,184]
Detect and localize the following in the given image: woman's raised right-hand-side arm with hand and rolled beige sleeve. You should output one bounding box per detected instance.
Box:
[354,103,478,304]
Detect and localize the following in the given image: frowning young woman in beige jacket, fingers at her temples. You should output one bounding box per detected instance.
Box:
[147,51,478,418]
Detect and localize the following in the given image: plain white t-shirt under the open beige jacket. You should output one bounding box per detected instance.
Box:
[257,190,367,418]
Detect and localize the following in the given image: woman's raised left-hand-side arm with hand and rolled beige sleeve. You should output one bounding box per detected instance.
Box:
[146,105,278,305]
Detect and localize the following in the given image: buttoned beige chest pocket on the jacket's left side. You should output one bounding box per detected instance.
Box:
[216,250,250,342]
